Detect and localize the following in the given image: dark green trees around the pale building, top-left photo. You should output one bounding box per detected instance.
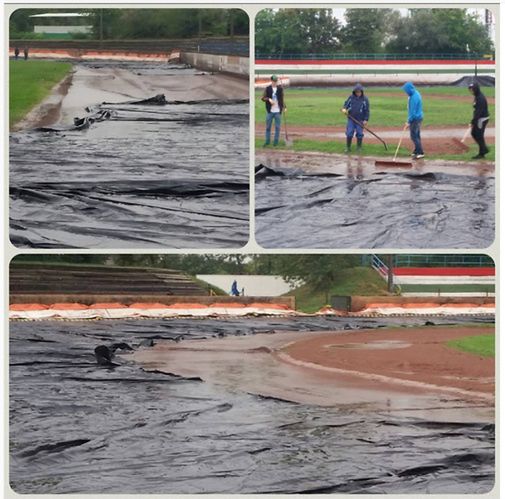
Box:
[9,9,249,40]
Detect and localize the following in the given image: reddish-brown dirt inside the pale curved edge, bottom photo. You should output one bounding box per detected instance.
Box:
[283,327,495,394]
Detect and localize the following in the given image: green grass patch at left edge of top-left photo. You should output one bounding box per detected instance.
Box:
[9,60,72,126]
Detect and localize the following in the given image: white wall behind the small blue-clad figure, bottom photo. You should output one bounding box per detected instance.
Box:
[196,274,293,296]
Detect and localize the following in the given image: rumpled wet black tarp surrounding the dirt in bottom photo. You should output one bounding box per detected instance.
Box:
[10,318,495,493]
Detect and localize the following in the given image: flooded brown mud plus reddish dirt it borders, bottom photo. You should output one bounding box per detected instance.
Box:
[132,327,494,421]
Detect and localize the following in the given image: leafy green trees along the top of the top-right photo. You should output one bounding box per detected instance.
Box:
[255,8,494,57]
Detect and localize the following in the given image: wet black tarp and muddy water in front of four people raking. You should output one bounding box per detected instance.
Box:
[256,151,495,249]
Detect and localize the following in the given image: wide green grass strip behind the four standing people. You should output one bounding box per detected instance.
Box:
[255,87,494,130]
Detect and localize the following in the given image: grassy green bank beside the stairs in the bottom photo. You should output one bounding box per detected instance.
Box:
[286,267,388,314]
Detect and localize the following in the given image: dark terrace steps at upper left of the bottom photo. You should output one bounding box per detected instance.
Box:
[10,263,208,296]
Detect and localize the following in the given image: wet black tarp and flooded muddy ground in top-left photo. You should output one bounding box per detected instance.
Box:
[9,63,249,248]
